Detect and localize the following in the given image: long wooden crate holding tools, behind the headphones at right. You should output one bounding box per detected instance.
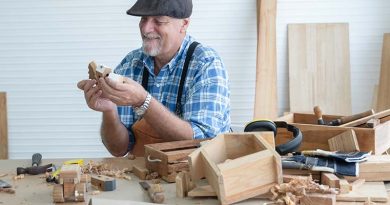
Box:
[275,113,390,155]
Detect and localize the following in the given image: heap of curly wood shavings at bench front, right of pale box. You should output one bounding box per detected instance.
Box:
[271,176,338,205]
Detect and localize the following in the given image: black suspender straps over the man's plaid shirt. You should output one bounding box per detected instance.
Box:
[142,41,199,116]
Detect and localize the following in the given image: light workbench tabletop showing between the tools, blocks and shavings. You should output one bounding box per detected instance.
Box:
[0,158,266,205]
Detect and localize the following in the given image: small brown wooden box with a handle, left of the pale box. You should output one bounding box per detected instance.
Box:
[145,139,204,182]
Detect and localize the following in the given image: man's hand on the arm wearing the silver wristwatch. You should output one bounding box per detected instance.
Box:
[99,78,147,107]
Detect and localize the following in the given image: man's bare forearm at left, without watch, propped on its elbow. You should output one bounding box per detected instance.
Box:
[100,111,129,157]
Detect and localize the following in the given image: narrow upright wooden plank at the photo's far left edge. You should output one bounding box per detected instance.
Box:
[0,92,8,159]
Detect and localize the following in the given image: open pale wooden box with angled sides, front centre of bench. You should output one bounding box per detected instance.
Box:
[190,132,282,204]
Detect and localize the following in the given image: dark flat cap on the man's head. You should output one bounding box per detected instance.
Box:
[126,0,192,19]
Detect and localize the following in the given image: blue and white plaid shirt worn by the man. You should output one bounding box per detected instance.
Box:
[114,35,230,149]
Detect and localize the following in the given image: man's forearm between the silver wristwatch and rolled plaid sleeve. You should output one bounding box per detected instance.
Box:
[144,98,193,141]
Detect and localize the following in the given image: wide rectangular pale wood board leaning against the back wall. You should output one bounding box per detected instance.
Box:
[288,23,352,115]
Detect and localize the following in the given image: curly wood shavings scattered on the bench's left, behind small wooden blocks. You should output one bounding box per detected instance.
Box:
[82,160,131,180]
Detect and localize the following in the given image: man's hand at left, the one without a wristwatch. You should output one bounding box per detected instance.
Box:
[77,80,116,112]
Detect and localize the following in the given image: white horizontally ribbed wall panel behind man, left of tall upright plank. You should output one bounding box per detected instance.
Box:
[0,0,256,159]
